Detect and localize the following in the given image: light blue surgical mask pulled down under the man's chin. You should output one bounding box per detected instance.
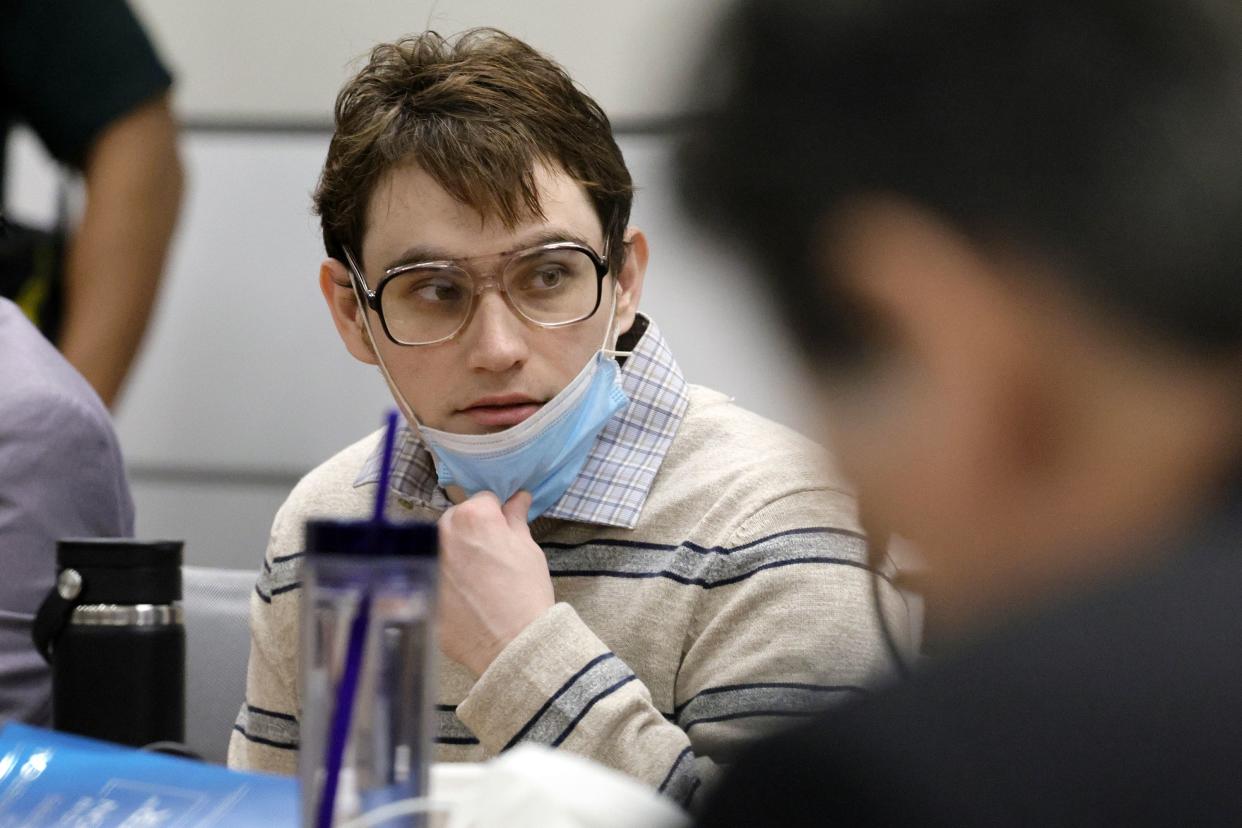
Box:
[419,350,630,520]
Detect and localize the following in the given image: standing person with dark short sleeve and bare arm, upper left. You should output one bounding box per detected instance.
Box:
[0,0,183,406]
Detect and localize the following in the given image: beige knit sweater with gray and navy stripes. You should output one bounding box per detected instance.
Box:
[229,386,909,804]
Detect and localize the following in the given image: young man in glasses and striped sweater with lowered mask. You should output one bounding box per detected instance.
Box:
[230,30,907,802]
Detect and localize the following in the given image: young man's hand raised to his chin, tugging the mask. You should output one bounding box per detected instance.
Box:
[440,492,555,675]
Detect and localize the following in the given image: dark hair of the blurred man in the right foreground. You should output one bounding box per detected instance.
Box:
[681,0,1242,356]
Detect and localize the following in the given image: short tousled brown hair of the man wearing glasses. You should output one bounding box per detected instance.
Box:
[314,29,633,271]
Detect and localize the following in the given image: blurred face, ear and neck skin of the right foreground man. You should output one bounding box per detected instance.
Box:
[821,196,1236,626]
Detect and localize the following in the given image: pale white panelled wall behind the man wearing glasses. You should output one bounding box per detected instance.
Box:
[6,0,800,567]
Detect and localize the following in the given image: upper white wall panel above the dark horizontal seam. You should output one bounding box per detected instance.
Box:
[130,0,724,120]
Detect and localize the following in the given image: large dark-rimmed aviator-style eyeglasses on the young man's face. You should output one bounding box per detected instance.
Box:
[345,242,609,345]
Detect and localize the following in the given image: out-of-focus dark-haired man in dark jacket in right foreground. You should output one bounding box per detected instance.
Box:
[682,0,1242,828]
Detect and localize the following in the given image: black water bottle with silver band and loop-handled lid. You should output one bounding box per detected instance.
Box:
[34,539,185,746]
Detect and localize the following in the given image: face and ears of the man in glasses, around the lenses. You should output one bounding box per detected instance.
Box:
[320,164,646,434]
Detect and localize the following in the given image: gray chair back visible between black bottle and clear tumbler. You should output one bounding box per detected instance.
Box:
[181,566,257,763]
